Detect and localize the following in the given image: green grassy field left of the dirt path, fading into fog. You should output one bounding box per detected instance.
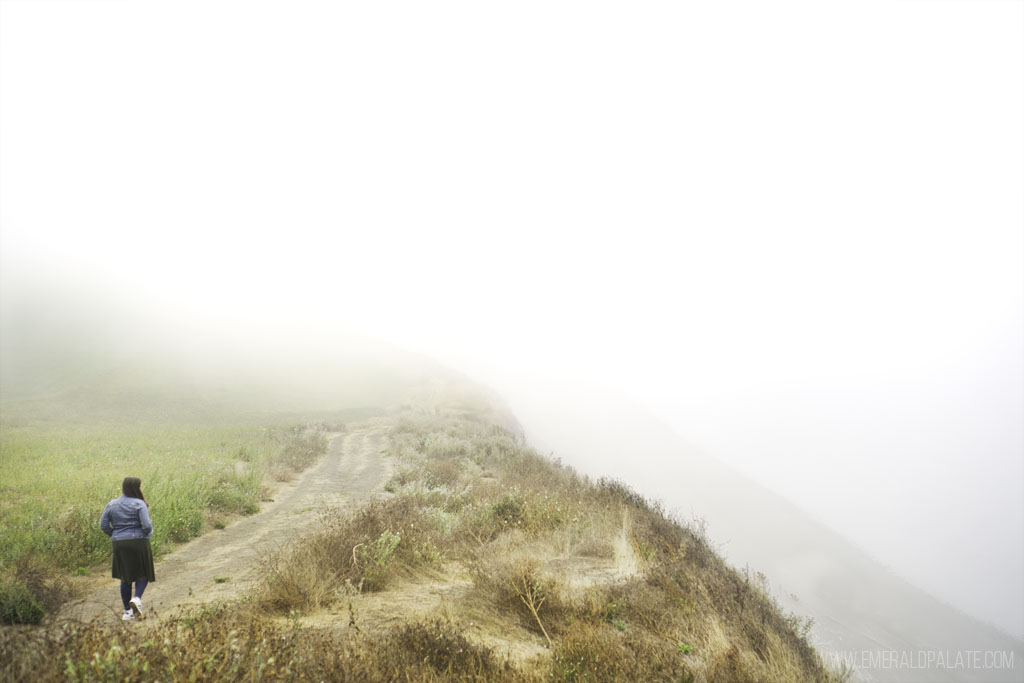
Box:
[0,387,372,621]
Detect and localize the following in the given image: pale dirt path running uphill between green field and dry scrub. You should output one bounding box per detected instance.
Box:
[59,420,392,620]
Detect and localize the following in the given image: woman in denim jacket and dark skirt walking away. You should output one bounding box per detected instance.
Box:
[99,477,157,622]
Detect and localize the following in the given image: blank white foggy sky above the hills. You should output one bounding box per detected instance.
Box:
[0,0,1024,637]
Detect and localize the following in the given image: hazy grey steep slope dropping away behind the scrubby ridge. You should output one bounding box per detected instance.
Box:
[516,387,1024,683]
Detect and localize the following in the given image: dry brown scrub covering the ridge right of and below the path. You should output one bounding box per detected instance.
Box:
[0,395,845,683]
